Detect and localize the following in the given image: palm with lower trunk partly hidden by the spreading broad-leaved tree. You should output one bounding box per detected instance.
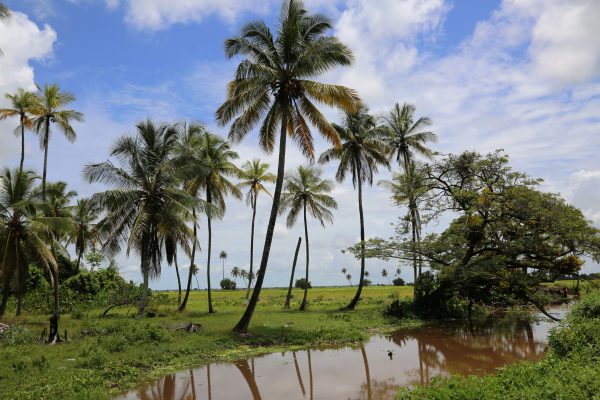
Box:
[384,103,437,282]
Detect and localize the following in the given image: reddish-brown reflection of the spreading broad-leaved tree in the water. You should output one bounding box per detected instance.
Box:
[392,320,545,384]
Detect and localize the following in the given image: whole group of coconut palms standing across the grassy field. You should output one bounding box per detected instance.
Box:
[0,0,436,332]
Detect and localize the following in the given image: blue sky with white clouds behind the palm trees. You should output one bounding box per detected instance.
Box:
[0,0,600,289]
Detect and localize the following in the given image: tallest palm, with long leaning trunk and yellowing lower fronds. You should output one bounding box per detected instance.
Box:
[217,0,360,332]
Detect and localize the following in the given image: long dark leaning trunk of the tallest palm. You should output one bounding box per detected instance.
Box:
[233,113,287,333]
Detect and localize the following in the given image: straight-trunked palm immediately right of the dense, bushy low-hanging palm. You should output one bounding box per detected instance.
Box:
[199,132,242,313]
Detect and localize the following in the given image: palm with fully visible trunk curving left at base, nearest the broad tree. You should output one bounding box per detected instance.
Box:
[319,108,389,310]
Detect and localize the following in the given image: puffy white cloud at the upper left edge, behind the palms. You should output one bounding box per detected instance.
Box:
[0,12,56,165]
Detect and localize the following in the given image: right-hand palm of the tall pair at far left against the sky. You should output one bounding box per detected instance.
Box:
[34,85,83,202]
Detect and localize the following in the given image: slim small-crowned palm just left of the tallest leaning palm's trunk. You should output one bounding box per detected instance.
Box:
[238,158,277,301]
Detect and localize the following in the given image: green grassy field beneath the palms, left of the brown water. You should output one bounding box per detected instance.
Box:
[0,286,412,400]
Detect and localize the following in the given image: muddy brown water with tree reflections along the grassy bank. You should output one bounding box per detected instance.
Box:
[119,309,563,400]
